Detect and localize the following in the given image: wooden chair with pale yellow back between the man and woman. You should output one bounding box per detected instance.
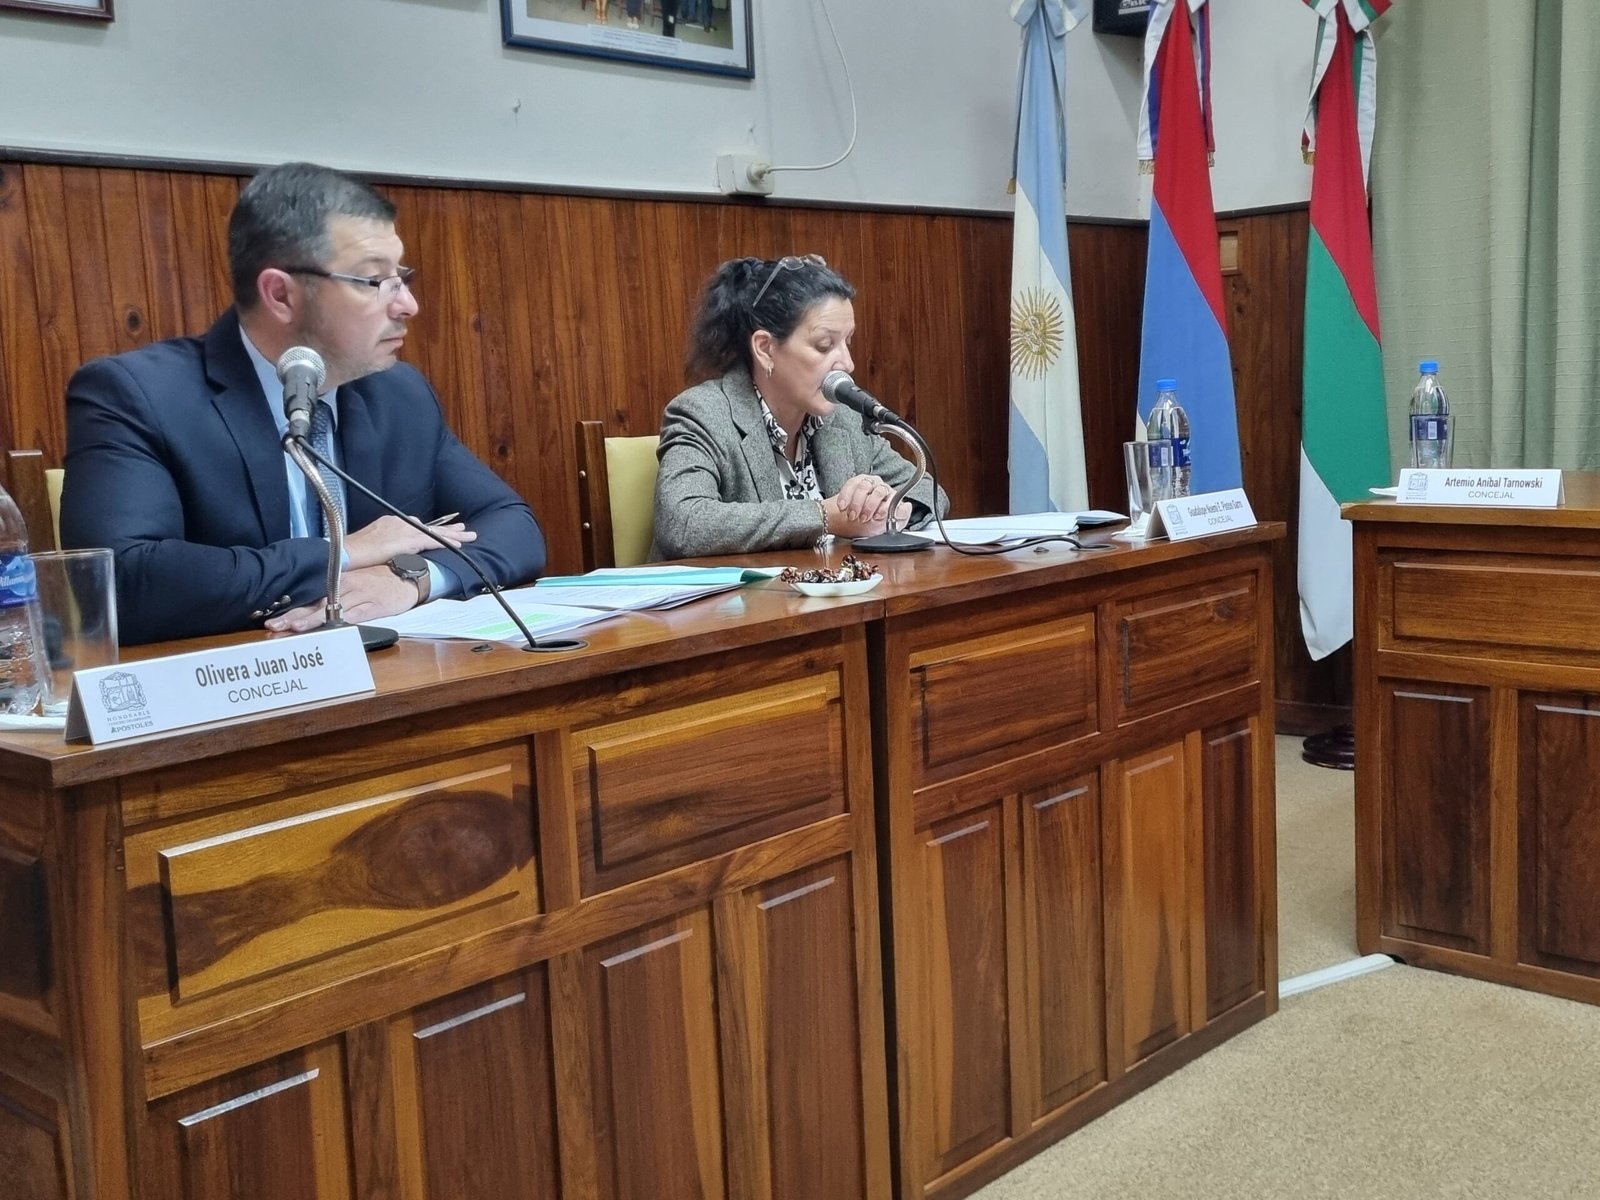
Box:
[578,421,661,571]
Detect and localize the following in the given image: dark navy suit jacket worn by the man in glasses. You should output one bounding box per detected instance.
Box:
[61,310,544,645]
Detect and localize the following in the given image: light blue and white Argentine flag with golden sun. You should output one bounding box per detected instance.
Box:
[1010,0,1090,512]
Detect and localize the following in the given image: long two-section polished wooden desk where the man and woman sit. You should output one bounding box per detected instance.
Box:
[0,528,1278,1200]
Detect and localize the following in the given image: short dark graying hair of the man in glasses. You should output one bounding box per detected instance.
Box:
[227,163,395,310]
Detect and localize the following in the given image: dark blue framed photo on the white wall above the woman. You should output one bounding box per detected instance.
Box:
[502,0,755,78]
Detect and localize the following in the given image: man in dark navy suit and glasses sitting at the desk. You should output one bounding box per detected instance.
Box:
[61,163,544,643]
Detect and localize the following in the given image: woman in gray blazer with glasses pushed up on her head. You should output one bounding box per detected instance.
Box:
[651,254,949,558]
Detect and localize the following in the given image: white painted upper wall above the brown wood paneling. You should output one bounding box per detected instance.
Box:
[0,0,1314,218]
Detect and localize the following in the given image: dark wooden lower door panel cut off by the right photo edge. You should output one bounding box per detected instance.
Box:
[1517,696,1600,978]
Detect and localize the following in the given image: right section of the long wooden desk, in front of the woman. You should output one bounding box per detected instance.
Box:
[872,525,1282,1200]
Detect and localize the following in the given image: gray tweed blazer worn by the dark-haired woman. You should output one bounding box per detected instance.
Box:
[650,368,950,558]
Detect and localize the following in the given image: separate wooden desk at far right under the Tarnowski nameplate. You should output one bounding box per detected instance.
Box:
[1346,472,1600,1003]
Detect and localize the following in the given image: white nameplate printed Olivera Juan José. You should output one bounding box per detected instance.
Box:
[66,626,373,744]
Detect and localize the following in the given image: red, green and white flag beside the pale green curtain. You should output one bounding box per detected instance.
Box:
[1299,0,1394,659]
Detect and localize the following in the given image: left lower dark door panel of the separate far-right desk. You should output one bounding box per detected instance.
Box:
[1379,680,1490,955]
